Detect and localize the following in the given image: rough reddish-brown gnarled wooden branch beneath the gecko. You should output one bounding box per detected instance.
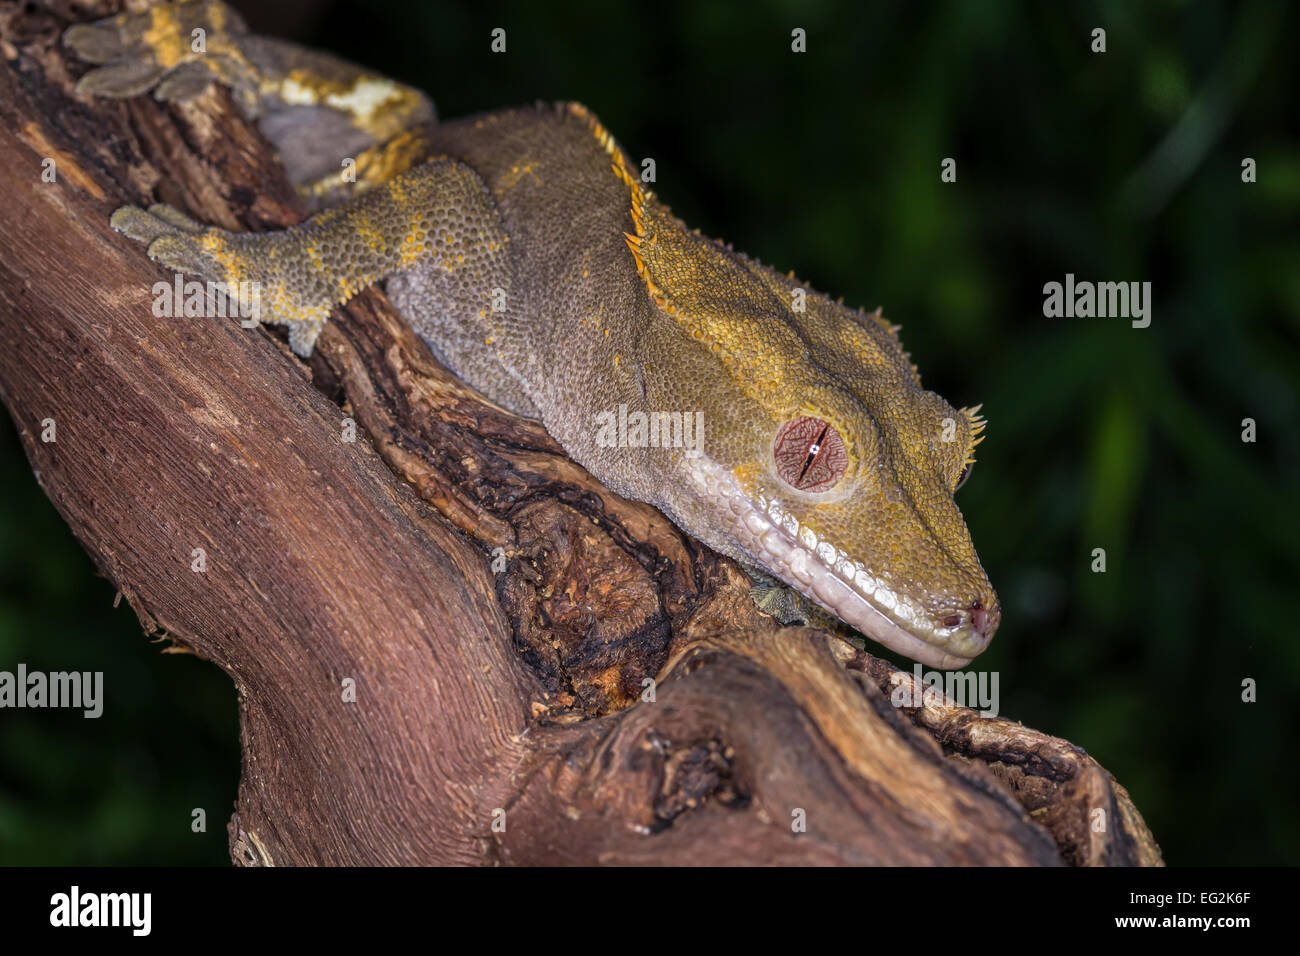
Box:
[0,1,1160,865]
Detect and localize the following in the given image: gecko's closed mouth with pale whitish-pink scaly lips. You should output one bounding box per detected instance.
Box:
[692,460,998,670]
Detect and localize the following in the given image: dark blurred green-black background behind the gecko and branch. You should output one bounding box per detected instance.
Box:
[0,0,1300,864]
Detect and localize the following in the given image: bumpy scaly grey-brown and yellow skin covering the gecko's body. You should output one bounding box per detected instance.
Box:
[70,3,1000,667]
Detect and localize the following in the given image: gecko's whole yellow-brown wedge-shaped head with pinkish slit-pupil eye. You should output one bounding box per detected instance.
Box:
[629,204,1001,667]
